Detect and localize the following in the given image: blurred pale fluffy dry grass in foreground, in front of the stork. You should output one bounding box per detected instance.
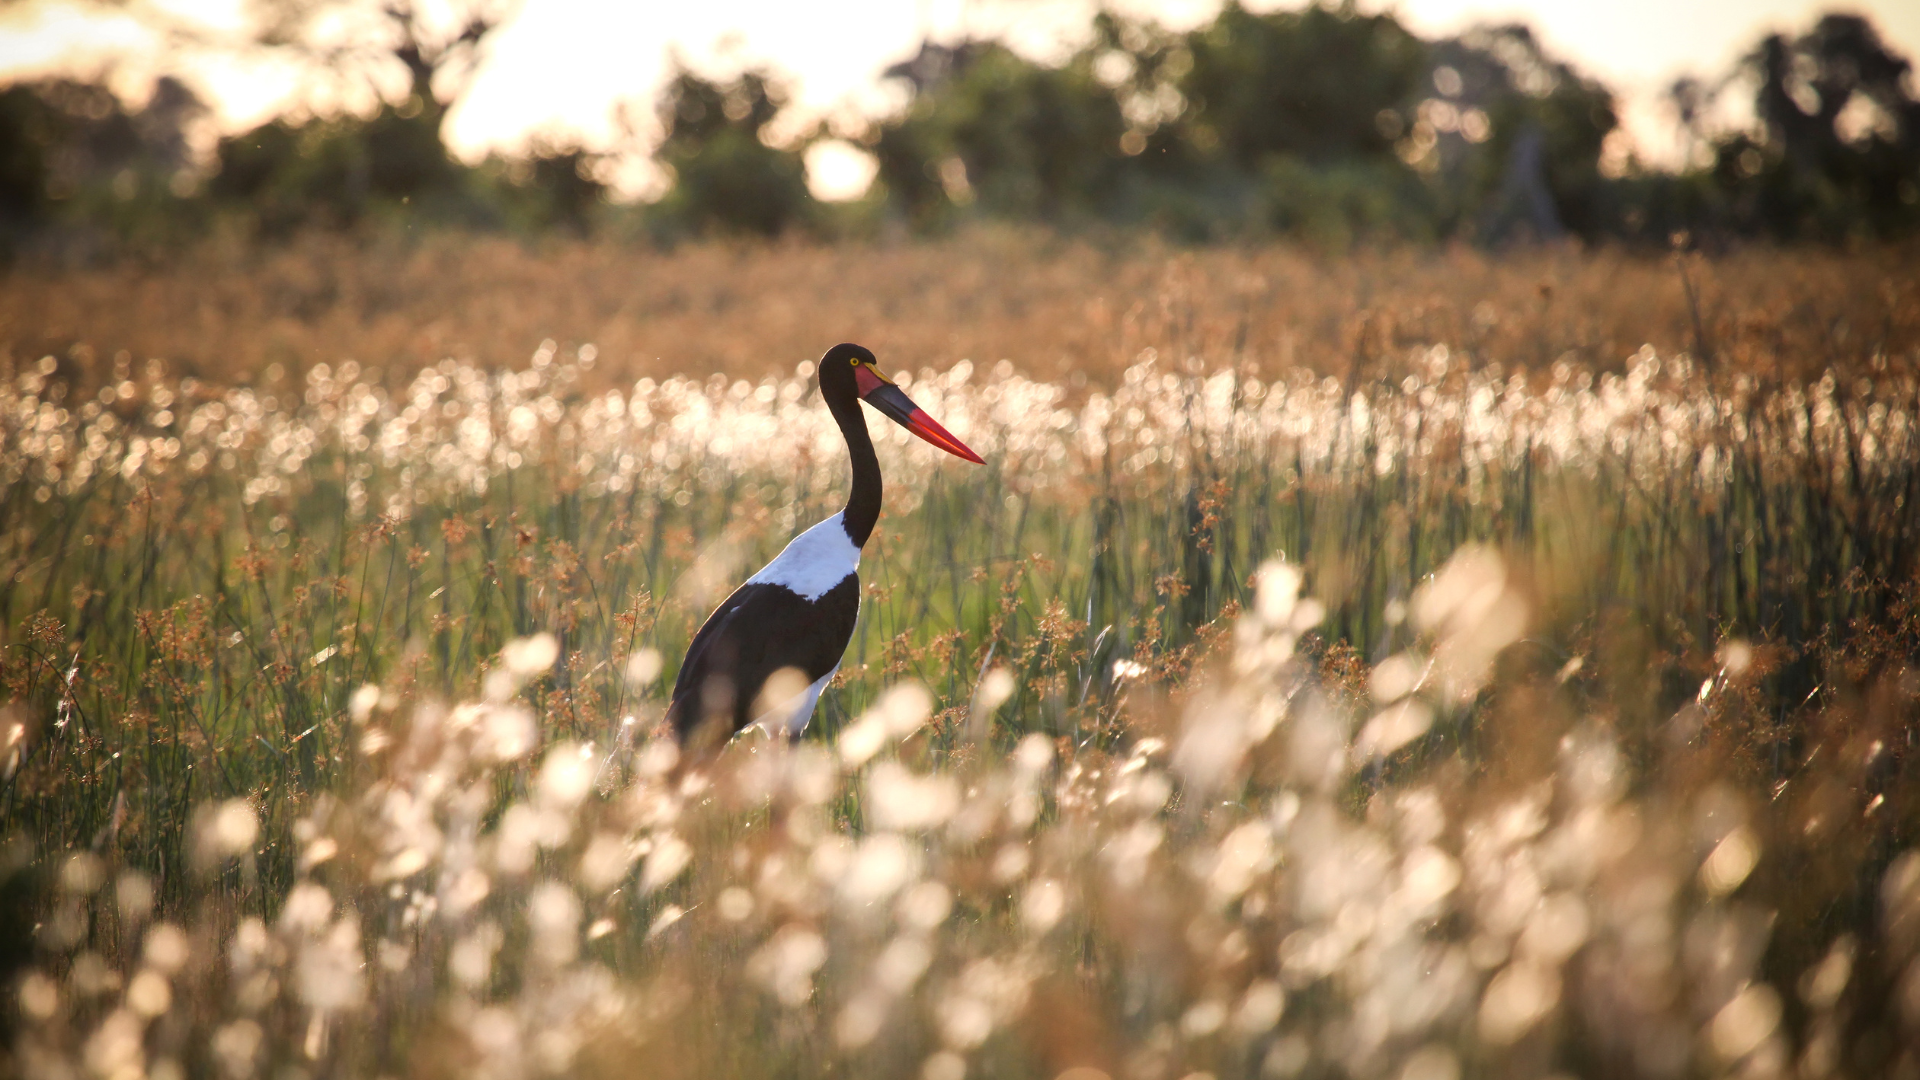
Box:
[11,564,1920,1080]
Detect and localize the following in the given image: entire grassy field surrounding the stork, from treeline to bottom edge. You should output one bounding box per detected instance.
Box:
[0,236,1920,1080]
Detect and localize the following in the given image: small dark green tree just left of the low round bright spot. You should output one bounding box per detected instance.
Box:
[653,60,814,236]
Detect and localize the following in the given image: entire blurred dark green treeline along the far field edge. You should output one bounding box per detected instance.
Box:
[0,4,1920,250]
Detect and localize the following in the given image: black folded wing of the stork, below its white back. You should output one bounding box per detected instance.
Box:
[666,575,860,742]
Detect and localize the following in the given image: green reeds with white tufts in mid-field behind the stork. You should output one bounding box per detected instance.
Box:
[0,350,1920,896]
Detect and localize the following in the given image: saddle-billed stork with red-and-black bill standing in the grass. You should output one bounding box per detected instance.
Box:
[666,344,985,749]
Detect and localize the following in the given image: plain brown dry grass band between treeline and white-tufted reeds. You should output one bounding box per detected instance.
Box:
[0,233,1920,386]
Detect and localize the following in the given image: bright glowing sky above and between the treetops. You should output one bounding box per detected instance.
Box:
[0,0,1920,198]
